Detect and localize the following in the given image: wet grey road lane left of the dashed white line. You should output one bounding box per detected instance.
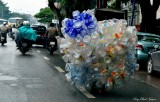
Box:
[0,38,86,102]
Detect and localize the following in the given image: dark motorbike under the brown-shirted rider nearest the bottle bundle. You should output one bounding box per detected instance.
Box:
[47,38,57,55]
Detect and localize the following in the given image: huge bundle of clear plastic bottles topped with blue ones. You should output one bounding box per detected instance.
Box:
[60,10,138,90]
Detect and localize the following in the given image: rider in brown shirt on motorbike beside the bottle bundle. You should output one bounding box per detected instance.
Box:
[46,23,58,50]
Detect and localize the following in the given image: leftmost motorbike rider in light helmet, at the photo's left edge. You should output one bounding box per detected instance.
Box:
[0,22,9,43]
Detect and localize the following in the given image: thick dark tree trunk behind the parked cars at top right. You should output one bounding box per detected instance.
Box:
[140,0,160,33]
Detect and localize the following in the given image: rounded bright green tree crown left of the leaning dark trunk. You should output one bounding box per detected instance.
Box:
[35,7,55,23]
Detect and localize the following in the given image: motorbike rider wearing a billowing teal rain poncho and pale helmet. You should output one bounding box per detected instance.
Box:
[15,21,37,49]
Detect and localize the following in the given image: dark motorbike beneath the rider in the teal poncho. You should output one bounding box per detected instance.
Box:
[19,39,32,55]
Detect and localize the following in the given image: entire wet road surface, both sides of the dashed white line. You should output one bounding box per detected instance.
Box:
[0,38,160,102]
